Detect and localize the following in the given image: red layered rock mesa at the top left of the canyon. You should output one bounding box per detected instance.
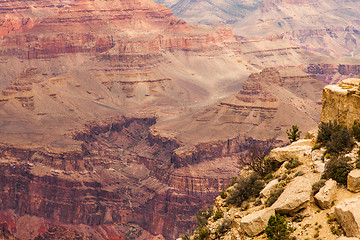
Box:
[0,0,234,59]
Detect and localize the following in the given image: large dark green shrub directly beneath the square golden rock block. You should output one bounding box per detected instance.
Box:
[316,121,354,154]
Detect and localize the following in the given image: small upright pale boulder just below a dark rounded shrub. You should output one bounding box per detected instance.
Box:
[314,179,337,209]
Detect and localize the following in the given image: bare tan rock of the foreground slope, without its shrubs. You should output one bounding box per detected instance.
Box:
[190,78,360,240]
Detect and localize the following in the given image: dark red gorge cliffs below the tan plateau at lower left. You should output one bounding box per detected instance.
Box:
[0,118,245,239]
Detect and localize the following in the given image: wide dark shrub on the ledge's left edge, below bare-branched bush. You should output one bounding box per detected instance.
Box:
[225,174,265,207]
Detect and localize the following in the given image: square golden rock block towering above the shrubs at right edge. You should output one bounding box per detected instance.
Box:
[321,78,360,128]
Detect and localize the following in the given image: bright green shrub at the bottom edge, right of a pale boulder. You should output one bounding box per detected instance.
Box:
[265,214,291,240]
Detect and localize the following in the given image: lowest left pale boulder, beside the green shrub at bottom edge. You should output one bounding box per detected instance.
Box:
[240,208,275,236]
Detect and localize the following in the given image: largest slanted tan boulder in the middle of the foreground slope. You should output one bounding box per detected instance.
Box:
[271,175,315,215]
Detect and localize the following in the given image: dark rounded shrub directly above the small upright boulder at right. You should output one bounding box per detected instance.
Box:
[324,156,353,186]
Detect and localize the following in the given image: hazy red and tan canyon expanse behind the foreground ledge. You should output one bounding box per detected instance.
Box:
[0,0,360,239]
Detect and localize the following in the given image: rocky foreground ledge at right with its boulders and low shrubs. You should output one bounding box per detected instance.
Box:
[190,79,360,240]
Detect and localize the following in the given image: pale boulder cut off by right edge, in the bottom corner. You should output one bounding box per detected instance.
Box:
[335,196,360,237]
